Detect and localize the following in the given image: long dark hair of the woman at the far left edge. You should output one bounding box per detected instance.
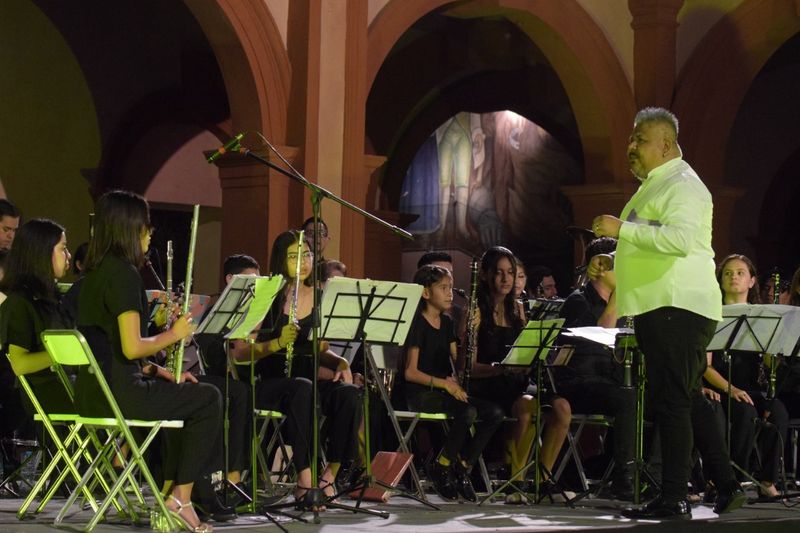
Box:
[0,218,64,303]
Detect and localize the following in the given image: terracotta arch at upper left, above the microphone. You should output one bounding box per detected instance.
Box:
[185,0,291,143]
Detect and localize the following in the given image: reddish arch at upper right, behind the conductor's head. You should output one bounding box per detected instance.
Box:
[673,0,800,186]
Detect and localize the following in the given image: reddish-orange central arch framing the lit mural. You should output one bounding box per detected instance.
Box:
[367,0,636,187]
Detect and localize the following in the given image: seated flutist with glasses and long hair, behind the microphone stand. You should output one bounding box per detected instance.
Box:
[234,231,362,510]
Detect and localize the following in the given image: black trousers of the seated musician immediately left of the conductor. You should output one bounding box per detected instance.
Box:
[558,377,636,477]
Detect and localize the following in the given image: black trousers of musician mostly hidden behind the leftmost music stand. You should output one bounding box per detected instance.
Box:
[197,375,251,472]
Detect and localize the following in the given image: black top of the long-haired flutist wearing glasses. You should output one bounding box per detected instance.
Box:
[256,288,314,379]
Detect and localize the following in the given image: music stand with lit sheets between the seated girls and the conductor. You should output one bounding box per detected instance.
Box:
[478,318,571,505]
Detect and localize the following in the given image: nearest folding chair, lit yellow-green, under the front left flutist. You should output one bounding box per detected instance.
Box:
[42,330,183,531]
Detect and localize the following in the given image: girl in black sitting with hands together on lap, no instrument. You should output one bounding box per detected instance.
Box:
[405,265,504,502]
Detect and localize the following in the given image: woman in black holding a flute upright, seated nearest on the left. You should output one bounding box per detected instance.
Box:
[77,191,222,532]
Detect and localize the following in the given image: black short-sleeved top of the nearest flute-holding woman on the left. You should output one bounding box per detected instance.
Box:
[77,255,148,389]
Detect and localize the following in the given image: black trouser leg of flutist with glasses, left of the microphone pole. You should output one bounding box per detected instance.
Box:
[256,378,311,472]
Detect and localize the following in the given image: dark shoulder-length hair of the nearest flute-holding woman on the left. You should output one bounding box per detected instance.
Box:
[84,191,150,272]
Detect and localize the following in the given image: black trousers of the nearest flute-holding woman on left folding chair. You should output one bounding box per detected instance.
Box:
[114,380,222,485]
